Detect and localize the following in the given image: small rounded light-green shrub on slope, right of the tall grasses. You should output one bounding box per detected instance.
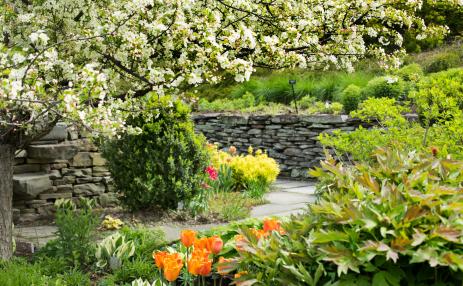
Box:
[362,76,405,99]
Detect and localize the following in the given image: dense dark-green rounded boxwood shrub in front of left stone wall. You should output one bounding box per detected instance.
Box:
[102,97,209,210]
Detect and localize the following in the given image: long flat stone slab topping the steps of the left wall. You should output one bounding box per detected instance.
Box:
[27,143,78,160]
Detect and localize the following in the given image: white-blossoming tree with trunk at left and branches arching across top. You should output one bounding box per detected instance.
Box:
[0,0,458,259]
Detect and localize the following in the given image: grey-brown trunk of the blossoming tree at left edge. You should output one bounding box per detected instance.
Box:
[0,144,15,260]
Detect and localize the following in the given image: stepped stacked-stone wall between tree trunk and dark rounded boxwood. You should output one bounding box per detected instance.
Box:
[13,125,115,222]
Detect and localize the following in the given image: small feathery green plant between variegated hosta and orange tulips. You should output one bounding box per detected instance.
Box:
[119,226,166,262]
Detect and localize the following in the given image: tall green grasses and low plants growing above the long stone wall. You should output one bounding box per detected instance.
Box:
[200,70,373,113]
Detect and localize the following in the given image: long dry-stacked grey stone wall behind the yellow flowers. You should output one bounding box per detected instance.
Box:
[193,113,361,178]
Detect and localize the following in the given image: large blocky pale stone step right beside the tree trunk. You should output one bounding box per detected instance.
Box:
[13,173,52,199]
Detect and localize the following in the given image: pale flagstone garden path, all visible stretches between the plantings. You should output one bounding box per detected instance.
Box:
[15,179,315,246]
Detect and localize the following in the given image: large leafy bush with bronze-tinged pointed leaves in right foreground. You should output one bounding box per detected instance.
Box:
[238,149,463,286]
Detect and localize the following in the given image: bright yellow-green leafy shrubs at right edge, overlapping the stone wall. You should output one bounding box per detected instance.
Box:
[320,69,463,161]
